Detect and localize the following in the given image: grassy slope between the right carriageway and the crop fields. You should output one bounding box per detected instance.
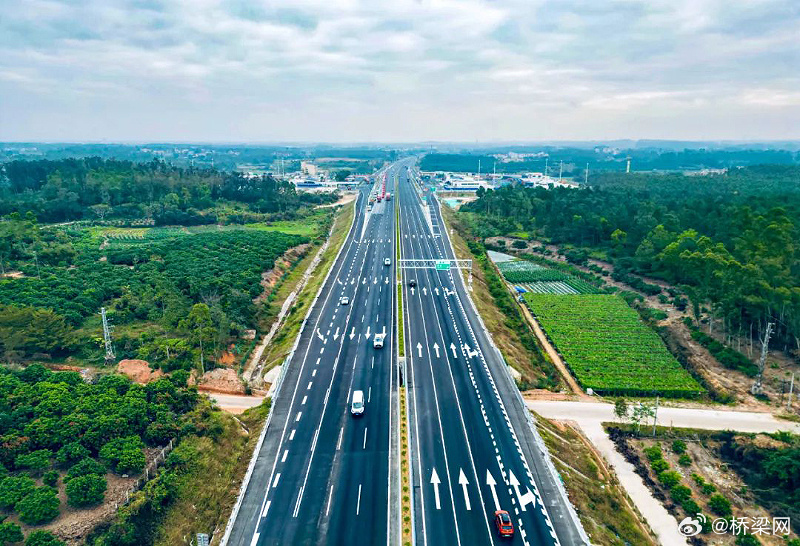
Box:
[441,206,561,389]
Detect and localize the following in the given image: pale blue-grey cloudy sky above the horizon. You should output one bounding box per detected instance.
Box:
[0,0,800,142]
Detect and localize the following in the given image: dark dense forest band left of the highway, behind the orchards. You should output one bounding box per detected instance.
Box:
[0,157,336,225]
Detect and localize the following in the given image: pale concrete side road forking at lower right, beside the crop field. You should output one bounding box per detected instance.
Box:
[526,400,800,546]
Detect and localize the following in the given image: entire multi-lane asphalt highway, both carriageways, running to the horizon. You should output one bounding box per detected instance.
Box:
[223,160,583,546]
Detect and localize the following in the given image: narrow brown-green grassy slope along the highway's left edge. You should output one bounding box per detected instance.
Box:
[261,201,355,371]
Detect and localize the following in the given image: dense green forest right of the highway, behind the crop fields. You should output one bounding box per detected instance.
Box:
[461,166,800,350]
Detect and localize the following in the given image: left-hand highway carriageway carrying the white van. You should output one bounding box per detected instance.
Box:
[227,164,400,546]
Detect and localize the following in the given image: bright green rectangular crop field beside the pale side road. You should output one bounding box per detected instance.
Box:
[525,293,703,397]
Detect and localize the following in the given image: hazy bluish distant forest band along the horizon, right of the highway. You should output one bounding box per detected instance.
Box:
[420,146,800,173]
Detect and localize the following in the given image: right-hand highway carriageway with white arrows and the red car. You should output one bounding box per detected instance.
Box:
[398,167,583,546]
